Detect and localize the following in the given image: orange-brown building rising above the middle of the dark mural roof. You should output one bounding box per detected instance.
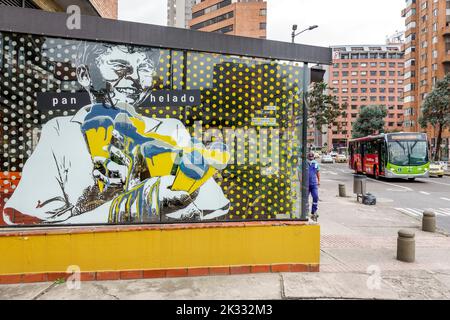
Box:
[189,0,267,39]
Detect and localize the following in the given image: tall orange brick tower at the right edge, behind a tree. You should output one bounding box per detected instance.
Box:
[402,0,450,158]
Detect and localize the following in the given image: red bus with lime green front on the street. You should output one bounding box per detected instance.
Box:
[348,133,430,180]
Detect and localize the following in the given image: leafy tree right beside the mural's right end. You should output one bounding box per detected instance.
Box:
[308,82,346,132]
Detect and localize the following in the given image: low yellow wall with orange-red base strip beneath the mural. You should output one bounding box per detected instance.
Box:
[0,222,320,284]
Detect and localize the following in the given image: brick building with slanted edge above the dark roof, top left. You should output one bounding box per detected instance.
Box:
[0,0,118,19]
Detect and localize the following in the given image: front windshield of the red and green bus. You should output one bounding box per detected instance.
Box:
[389,141,428,166]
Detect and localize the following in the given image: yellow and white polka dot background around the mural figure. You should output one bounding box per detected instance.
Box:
[0,33,302,221]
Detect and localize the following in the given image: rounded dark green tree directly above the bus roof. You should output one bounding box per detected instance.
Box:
[353,105,387,138]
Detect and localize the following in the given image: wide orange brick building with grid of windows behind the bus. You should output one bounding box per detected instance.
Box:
[328,44,404,149]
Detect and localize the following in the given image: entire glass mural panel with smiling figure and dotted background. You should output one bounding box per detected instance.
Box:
[0,33,302,226]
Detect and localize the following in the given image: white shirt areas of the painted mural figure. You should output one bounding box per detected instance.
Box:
[4,106,229,224]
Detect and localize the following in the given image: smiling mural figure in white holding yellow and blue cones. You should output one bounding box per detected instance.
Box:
[3,42,230,225]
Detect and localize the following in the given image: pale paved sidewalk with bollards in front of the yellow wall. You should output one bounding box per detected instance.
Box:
[0,182,450,300]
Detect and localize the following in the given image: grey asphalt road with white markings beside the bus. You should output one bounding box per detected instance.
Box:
[321,164,450,233]
